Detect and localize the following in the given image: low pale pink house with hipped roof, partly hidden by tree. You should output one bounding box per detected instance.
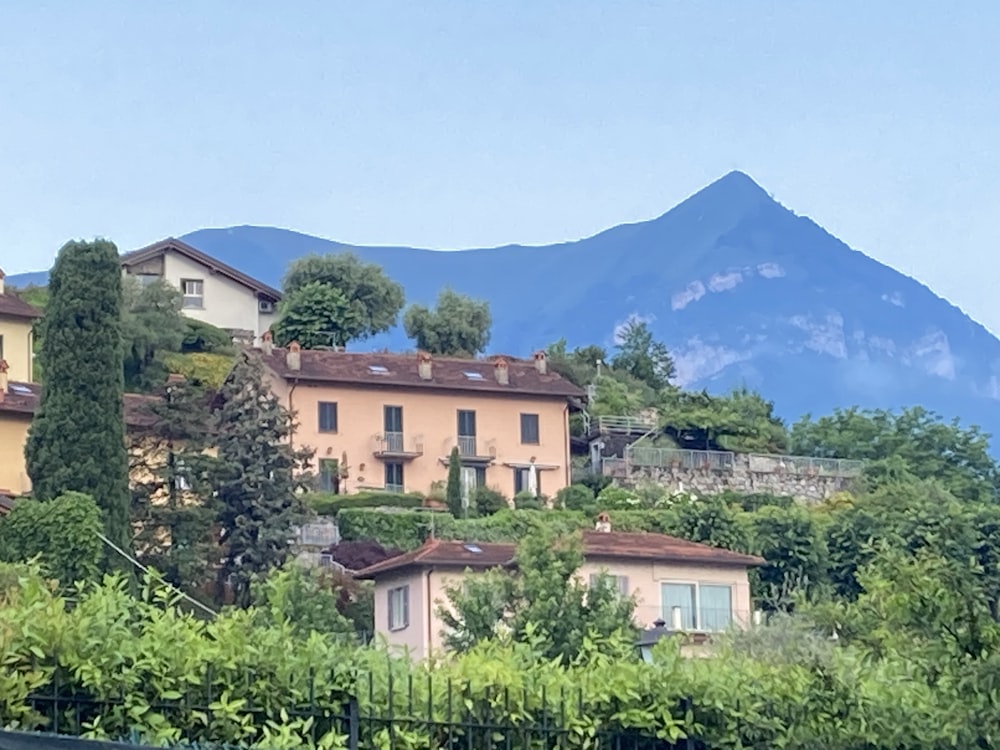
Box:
[356,524,763,659]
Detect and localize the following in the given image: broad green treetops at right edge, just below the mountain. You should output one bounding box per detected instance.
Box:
[791,406,1000,502]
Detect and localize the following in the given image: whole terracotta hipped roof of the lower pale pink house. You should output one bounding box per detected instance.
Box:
[355,531,764,578]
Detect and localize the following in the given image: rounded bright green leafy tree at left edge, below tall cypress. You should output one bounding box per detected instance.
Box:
[0,492,104,587]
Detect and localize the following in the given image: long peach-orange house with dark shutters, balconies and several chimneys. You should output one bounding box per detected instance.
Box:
[261,344,584,497]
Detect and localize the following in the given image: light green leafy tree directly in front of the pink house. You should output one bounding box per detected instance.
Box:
[439,532,635,661]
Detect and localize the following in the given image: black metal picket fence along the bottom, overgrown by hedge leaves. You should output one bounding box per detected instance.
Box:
[23,674,702,750]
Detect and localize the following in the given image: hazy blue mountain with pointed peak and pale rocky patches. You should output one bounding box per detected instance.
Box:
[10,172,1000,434]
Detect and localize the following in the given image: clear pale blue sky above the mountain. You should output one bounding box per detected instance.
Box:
[0,0,1000,332]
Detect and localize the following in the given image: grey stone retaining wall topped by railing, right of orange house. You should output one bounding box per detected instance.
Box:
[603,451,861,502]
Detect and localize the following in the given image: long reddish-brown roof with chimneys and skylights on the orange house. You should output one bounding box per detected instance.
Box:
[262,348,586,398]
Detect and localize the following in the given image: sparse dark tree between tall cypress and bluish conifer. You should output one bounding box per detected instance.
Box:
[129,378,218,591]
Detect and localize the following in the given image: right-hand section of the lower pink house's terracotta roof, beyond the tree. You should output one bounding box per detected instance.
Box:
[583,531,764,567]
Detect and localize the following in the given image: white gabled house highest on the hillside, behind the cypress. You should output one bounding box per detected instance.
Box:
[121,237,281,343]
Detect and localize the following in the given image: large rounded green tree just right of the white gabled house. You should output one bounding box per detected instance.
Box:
[274,253,405,349]
